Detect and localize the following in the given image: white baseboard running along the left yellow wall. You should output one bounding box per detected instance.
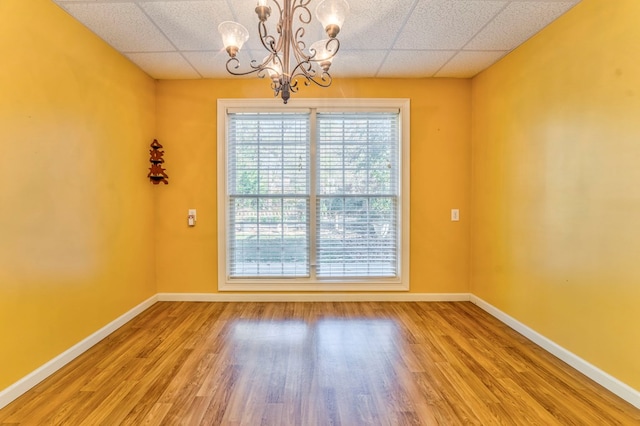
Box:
[0,295,158,409]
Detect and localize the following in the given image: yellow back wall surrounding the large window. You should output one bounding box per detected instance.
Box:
[156,79,471,293]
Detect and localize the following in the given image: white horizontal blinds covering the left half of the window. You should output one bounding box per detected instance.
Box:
[227,113,310,277]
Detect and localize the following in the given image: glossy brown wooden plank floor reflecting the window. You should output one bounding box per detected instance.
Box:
[0,302,640,426]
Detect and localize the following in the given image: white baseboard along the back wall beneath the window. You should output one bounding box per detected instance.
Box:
[158,293,471,302]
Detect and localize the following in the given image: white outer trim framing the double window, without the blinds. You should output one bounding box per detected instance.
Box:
[217,98,411,292]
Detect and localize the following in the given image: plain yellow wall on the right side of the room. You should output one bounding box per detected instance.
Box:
[471,0,640,389]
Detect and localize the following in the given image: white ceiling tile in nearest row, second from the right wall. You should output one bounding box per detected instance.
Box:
[394,0,507,50]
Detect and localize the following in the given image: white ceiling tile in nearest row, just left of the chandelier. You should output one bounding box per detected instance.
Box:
[140,0,233,50]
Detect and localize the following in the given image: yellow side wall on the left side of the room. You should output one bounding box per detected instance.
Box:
[0,0,161,390]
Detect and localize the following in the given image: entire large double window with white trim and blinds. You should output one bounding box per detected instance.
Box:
[218,100,409,290]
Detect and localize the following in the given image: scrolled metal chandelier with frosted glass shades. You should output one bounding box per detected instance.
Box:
[218,0,349,104]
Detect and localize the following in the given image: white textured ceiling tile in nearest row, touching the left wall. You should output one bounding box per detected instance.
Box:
[64,3,175,52]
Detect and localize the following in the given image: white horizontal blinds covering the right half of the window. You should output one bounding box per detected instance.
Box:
[315,112,399,277]
